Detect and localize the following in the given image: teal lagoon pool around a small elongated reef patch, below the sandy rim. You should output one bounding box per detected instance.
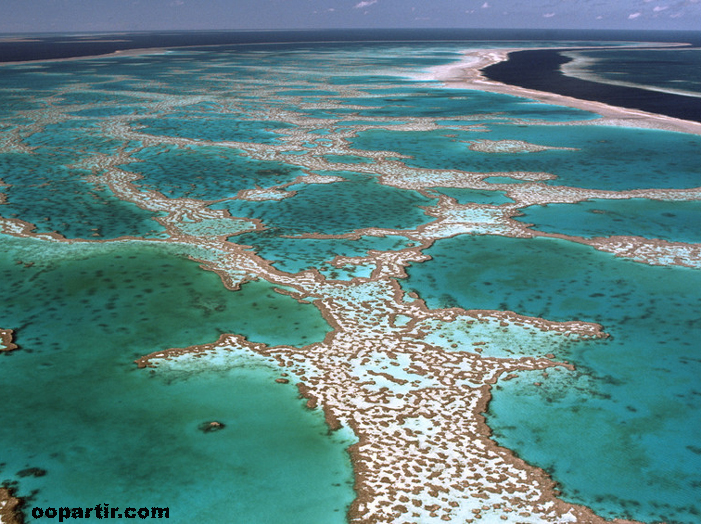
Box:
[351,124,701,191]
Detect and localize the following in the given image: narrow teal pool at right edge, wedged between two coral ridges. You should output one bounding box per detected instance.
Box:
[516,198,701,244]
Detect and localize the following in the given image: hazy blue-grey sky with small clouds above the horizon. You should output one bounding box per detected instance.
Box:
[0,0,701,33]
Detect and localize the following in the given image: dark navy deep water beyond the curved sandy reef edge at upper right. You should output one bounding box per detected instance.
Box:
[484,32,701,122]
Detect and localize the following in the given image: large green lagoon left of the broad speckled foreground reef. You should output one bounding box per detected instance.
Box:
[0,238,353,523]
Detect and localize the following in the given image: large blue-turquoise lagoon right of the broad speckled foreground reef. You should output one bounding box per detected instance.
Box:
[402,236,701,523]
